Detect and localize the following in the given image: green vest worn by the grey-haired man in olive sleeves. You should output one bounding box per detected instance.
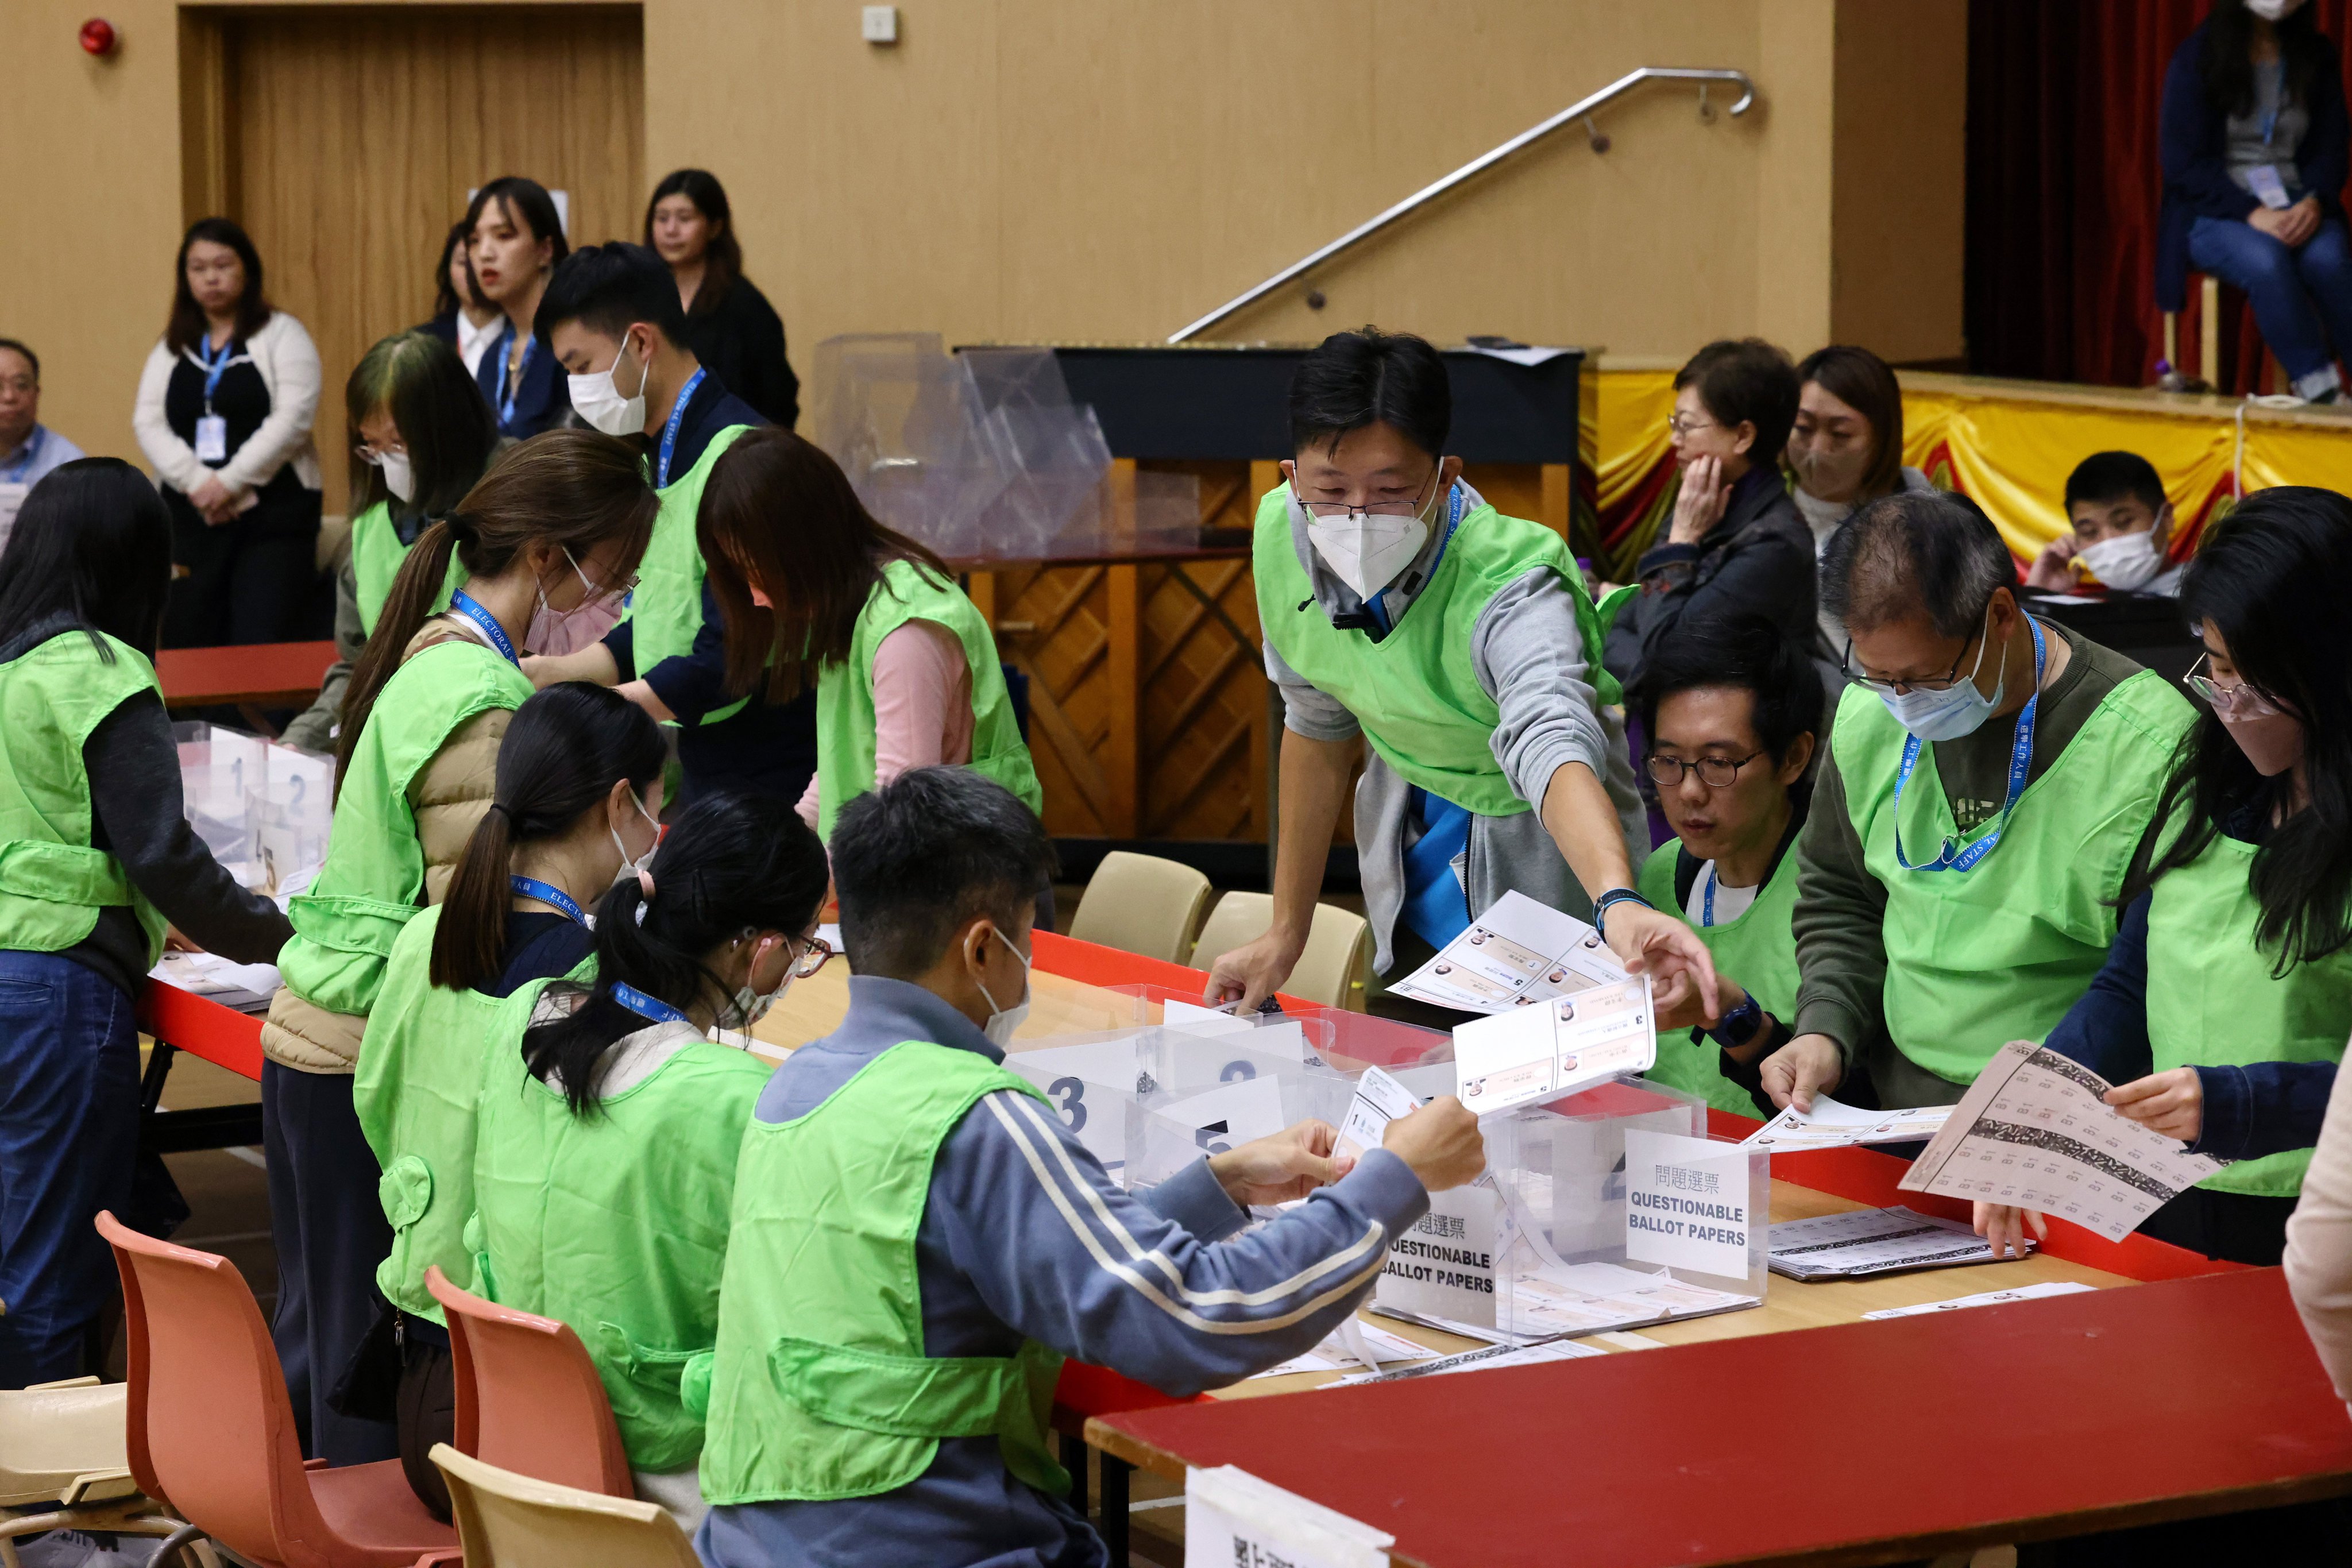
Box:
[1830,670,2195,1084]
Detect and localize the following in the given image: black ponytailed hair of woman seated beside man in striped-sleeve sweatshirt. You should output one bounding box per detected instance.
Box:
[522,794,825,1117]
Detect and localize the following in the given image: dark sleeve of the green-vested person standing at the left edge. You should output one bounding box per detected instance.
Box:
[82,691,294,964]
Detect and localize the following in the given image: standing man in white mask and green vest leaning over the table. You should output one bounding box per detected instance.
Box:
[1207,327,1714,1011]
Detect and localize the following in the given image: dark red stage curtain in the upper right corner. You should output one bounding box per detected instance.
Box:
[1964,0,2352,393]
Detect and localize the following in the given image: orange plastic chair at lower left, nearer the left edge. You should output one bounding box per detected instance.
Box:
[99,1213,461,1568]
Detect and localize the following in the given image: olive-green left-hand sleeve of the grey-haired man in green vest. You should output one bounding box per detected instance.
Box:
[1790,752,1886,1067]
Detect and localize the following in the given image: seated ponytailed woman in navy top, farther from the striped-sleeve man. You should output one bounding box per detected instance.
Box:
[353,682,668,1519]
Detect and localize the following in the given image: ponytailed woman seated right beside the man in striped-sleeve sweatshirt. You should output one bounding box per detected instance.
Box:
[473,794,828,1531]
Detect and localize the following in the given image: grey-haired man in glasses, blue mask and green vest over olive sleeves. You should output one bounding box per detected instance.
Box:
[1762,494,2192,1110]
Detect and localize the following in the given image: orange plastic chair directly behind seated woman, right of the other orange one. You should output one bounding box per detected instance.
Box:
[426,1265,638,1497]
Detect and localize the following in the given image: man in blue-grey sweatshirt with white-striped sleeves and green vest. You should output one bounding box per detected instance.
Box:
[685,766,1486,1568]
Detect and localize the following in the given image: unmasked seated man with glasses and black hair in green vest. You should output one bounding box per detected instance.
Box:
[1632,616,1821,1117]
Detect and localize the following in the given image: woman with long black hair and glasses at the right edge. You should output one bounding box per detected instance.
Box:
[1976,484,2352,1267]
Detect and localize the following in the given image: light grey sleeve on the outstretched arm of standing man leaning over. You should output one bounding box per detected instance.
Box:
[1470,566,1620,809]
